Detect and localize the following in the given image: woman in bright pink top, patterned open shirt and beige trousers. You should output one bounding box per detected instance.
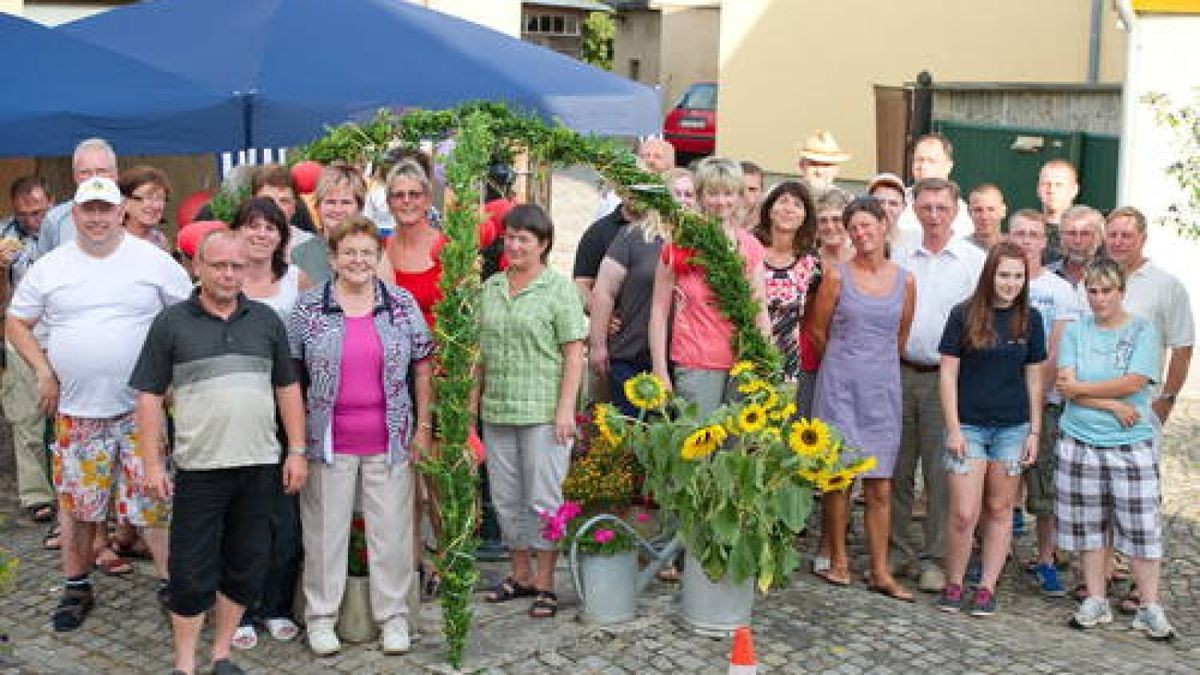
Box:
[288,215,433,655]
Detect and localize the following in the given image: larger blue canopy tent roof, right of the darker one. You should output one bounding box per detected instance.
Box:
[59,0,660,148]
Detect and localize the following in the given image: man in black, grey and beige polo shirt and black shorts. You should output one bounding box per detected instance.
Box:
[130,229,308,675]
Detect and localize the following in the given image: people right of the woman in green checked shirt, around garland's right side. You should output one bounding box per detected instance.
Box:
[574,131,1194,639]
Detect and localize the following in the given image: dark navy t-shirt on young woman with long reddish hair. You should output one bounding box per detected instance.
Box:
[937,303,1046,426]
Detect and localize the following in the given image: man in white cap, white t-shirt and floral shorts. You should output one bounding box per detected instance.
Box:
[5,177,191,631]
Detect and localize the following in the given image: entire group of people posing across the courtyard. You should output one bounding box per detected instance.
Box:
[0,124,1193,674]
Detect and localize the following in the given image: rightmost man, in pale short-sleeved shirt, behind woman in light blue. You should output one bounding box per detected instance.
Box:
[1104,207,1195,425]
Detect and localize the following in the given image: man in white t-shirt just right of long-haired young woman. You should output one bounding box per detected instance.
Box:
[1008,209,1080,597]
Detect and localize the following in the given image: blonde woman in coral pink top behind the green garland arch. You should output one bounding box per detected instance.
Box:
[649,157,770,414]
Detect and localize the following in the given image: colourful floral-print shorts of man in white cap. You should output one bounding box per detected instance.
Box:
[50,412,170,527]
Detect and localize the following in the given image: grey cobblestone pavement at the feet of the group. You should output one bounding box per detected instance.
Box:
[0,400,1200,675]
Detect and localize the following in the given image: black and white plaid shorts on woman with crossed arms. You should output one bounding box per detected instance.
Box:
[1055,435,1163,560]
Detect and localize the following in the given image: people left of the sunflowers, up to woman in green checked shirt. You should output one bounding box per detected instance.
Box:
[2,139,587,673]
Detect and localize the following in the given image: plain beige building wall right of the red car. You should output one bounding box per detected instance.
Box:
[718,0,1126,180]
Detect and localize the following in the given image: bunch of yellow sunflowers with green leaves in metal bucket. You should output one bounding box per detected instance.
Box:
[595,362,875,593]
